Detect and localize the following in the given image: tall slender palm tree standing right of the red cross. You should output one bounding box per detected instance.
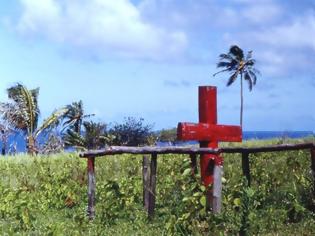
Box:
[213,45,260,127]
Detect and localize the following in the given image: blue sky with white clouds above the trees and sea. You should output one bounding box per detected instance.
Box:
[0,0,315,131]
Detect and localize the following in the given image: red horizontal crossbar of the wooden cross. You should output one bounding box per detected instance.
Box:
[177,122,242,142]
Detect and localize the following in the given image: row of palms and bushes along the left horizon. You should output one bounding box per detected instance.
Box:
[0,83,167,155]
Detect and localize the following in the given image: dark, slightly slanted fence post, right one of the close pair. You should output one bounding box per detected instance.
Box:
[148,154,157,219]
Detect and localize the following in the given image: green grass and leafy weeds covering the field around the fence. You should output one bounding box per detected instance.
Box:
[0,138,315,235]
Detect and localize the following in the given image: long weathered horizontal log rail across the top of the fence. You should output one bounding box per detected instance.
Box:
[80,143,315,158]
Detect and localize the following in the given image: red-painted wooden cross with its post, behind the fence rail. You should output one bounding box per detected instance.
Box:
[177,86,242,212]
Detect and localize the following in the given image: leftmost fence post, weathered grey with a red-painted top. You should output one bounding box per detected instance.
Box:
[87,157,96,220]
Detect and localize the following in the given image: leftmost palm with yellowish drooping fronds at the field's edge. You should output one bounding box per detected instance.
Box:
[0,83,68,154]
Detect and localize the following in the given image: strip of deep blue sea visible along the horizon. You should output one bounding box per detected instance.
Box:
[0,131,315,152]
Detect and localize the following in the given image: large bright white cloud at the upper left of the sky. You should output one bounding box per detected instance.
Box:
[17,0,187,60]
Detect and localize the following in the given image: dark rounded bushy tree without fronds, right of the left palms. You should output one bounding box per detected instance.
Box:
[109,117,155,146]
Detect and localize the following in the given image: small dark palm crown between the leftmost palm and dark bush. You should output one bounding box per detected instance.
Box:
[63,100,94,135]
